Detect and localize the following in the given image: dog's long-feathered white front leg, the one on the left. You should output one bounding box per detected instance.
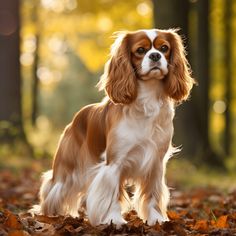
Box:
[86,163,126,227]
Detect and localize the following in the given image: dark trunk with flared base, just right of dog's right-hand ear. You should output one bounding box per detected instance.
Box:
[195,0,225,167]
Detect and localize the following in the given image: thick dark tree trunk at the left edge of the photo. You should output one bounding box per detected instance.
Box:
[0,0,25,142]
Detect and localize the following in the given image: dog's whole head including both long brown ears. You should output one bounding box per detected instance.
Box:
[99,29,194,104]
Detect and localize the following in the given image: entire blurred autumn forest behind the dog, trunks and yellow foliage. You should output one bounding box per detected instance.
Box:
[0,0,236,188]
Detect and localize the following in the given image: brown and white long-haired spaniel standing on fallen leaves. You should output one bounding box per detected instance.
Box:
[33,29,194,225]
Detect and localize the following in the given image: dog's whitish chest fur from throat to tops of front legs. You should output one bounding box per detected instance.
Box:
[115,80,174,173]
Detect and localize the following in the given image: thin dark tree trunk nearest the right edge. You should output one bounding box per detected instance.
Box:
[224,0,233,156]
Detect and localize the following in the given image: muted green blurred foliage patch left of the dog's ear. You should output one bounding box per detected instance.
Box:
[37,51,103,126]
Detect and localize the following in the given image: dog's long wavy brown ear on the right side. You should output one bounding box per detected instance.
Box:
[165,30,195,102]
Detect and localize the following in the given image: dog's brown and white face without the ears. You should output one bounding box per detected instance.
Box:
[130,30,171,80]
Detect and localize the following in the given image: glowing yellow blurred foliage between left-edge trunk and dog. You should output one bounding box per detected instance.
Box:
[20,0,153,152]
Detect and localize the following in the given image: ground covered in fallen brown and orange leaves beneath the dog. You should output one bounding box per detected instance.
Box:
[0,169,236,236]
